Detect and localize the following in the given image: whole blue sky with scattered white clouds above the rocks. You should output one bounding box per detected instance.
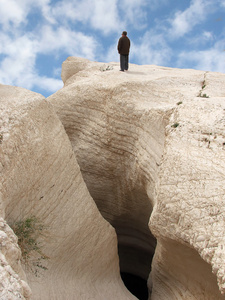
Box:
[0,0,225,97]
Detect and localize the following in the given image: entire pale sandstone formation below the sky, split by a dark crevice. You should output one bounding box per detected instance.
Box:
[0,57,225,300]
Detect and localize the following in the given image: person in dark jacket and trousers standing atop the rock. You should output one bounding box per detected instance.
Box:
[117,31,130,72]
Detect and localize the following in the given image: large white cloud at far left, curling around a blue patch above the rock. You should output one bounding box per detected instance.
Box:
[0,21,97,92]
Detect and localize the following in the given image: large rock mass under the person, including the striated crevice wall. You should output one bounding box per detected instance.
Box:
[48,57,225,300]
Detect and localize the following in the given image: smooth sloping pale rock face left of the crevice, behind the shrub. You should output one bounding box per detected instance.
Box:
[0,85,136,300]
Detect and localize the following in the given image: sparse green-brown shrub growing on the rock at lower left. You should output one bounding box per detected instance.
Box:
[11,216,49,276]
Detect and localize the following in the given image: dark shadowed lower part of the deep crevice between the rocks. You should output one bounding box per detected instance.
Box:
[96,188,156,300]
